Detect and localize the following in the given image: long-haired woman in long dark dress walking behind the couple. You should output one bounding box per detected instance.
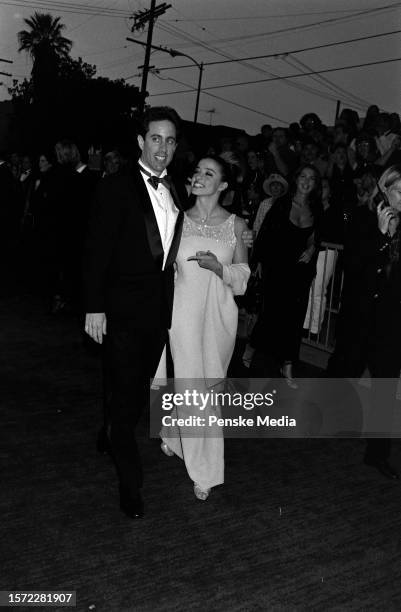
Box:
[251,165,322,389]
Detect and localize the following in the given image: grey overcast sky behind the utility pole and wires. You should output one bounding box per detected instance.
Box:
[0,0,401,134]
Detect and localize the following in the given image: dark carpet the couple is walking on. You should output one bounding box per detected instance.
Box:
[0,298,401,612]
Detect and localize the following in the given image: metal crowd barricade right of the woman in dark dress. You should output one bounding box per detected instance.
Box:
[303,242,344,353]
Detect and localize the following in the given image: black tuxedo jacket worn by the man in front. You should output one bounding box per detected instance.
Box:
[84,168,186,329]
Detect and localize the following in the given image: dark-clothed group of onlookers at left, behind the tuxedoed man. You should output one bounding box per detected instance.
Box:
[0,140,125,313]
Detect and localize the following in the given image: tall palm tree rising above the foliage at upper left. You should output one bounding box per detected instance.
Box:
[18,13,72,99]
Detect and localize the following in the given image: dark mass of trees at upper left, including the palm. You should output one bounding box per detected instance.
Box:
[9,13,141,149]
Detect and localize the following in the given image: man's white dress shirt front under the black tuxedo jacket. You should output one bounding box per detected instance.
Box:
[139,160,178,270]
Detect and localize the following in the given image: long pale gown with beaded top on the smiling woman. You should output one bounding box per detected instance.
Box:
[162,215,238,489]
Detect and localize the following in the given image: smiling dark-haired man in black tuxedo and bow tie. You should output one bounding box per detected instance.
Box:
[84,107,186,519]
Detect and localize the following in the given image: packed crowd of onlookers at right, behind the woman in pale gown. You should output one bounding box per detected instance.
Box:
[195,106,401,234]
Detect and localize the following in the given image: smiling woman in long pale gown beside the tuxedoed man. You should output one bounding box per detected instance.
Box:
[162,156,250,500]
